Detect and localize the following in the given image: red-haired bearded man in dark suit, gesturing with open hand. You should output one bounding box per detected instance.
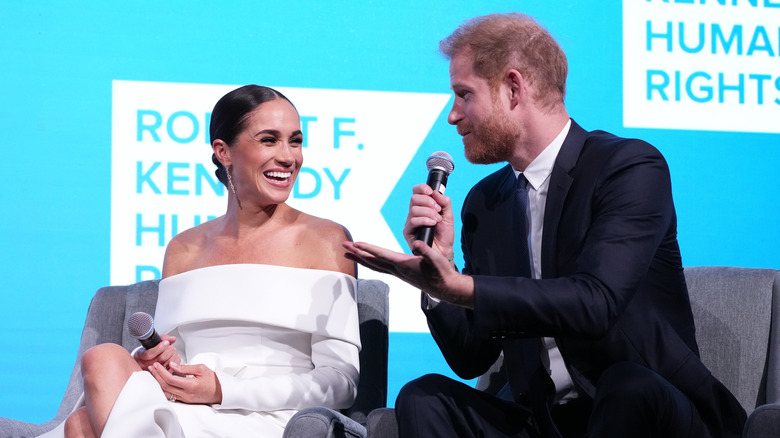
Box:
[344,14,745,438]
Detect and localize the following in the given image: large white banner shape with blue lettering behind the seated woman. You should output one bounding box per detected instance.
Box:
[111,81,449,332]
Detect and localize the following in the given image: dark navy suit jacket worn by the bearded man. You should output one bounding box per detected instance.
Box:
[424,121,746,437]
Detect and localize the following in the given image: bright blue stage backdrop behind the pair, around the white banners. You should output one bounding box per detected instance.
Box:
[0,0,780,422]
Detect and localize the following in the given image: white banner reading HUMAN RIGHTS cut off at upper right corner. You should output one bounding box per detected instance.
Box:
[620,0,780,133]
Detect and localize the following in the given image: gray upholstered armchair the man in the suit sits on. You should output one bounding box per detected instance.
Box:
[367,266,780,438]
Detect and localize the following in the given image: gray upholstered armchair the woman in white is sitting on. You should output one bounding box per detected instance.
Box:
[0,279,389,438]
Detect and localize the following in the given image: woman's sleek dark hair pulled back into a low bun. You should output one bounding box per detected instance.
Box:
[209,85,295,186]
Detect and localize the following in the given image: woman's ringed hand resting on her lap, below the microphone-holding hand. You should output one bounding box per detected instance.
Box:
[149,362,222,405]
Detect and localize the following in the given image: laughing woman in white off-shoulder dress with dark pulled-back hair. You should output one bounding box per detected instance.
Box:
[65,85,360,437]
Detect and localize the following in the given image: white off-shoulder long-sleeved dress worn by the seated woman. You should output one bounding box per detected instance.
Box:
[45,264,360,438]
